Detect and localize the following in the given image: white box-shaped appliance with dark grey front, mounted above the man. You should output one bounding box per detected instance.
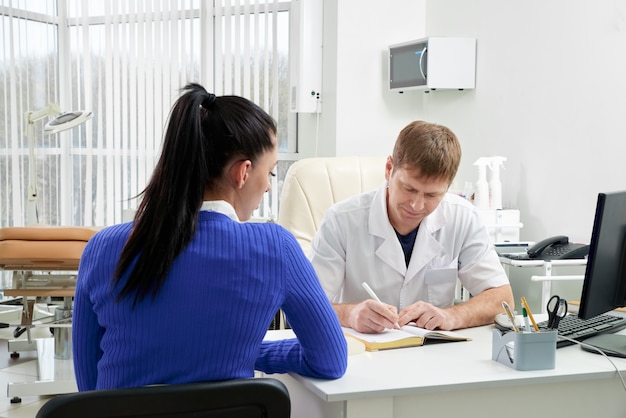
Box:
[389,36,476,92]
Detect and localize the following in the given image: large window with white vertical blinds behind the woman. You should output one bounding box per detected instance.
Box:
[0,0,296,226]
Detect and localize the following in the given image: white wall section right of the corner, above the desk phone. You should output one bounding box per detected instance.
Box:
[426,0,626,241]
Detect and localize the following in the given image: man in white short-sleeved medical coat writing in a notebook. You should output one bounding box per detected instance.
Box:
[310,121,514,333]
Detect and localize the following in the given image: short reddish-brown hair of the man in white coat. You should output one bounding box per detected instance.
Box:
[392,120,461,184]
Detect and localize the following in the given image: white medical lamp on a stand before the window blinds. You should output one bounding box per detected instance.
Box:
[24,103,93,225]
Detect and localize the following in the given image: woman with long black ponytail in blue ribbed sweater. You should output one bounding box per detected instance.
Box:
[72,84,347,391]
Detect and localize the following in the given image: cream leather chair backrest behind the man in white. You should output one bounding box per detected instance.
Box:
[278,157,387,253]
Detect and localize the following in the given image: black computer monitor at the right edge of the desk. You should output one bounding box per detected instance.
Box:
[578,191,626,318]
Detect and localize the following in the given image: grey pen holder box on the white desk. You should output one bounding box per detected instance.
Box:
[491,329,557,370]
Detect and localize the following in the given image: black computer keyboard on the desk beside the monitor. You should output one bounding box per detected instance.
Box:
[537,314,626,348]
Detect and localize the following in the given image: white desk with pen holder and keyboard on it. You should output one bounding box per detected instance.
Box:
[268,326,626,418]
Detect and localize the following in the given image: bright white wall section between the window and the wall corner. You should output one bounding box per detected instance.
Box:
[299,0,425,157]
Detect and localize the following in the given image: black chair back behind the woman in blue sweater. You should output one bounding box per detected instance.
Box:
[36,378,291,418]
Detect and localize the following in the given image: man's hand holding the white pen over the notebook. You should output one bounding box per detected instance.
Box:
[335,299,398,334]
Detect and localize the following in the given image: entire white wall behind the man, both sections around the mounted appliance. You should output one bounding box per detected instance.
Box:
[301,0,626,242]
